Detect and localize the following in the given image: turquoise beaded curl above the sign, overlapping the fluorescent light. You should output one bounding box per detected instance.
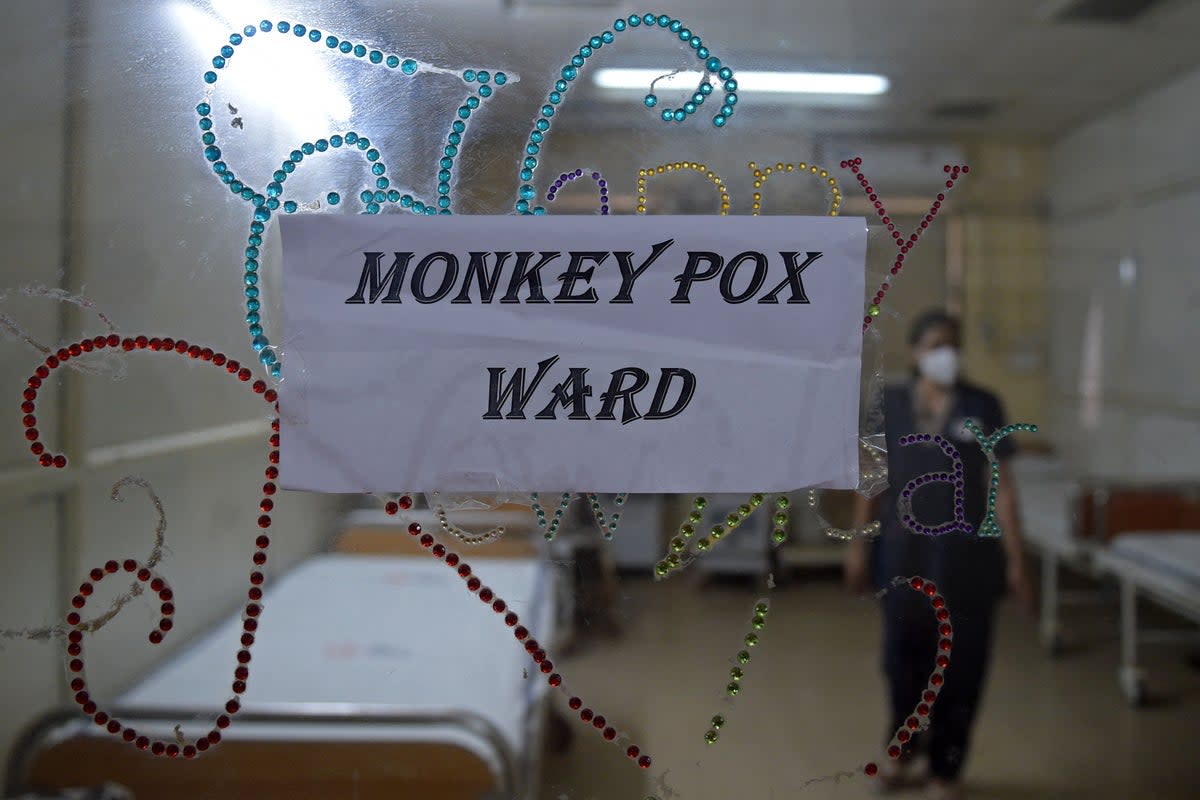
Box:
[515,13,738,215]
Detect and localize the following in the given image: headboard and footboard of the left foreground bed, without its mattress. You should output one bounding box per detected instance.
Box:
[5,507,554,800]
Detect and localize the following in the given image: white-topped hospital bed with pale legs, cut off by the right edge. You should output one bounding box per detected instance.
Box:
[1096,530,1200,705]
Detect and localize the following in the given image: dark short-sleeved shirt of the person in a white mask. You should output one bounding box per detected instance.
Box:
[871,383,1014,608]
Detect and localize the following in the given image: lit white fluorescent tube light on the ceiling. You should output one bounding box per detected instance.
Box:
[595,68,890,95]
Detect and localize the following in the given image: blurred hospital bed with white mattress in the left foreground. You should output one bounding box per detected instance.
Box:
[8,509,557,800]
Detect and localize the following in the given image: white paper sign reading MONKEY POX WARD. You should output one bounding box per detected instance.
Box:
[280,215,866,493]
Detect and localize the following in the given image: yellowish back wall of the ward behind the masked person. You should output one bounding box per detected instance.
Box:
[525,132,1050,520]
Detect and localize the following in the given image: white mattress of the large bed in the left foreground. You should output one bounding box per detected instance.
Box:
[118,551,554,772]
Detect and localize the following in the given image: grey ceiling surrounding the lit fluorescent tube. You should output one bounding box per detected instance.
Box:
[365,0,1200,138]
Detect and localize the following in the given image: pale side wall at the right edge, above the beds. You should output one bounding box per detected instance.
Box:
[1049,65,1200,480]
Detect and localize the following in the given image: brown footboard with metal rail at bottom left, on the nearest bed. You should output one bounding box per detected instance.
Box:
[6,706,523,800]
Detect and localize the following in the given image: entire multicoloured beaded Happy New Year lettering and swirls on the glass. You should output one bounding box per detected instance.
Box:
[0,14,1037,788]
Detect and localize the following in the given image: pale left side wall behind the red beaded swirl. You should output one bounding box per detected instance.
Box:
[0,1,340,778]
